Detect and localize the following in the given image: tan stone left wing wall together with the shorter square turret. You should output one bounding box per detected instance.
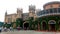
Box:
[5,9,22,23]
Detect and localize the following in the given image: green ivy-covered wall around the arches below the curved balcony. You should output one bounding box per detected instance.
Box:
[38,16,60,30]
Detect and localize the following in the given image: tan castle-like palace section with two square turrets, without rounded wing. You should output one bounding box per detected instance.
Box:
[4,5,35,27]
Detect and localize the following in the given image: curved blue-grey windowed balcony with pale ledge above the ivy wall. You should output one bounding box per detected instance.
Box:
[37,8,60,17]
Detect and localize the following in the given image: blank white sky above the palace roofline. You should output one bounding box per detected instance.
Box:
[0,0,60,22]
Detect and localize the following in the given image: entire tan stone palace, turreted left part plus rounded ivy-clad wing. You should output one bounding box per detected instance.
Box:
[5,1,60,31]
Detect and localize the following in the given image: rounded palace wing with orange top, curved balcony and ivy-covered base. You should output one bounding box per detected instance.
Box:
[37,1,60,31]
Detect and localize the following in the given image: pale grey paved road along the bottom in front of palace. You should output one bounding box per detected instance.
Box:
[0,30,60,34]
